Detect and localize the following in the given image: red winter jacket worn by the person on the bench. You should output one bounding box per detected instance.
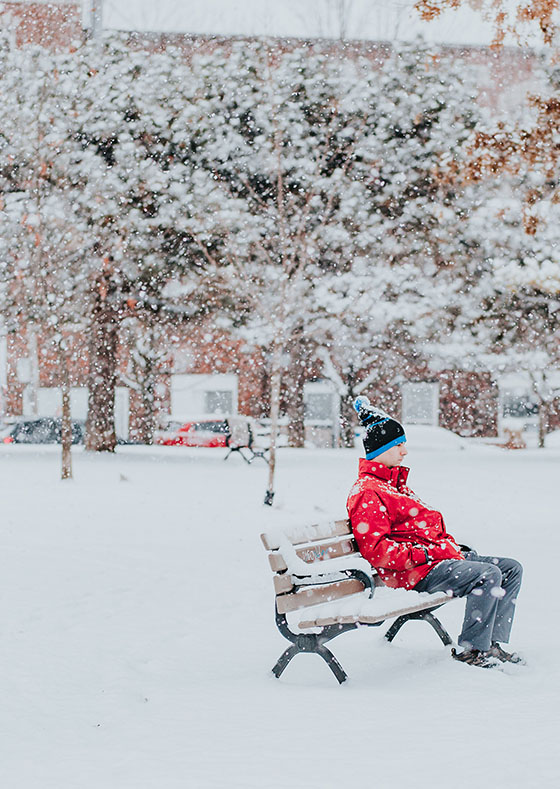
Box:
[346,458,464,589]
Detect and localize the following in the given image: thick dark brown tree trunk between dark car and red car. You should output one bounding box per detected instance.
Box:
[86,277,118,452]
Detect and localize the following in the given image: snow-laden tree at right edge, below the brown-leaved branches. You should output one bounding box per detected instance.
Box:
[428,186,560,446]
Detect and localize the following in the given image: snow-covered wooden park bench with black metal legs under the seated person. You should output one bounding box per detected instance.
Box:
[261,520,452,683]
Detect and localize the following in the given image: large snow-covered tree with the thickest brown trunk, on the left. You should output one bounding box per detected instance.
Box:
[0,29,214,450]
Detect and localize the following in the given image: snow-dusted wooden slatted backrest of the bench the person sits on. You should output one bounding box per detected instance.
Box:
[261,520,374,614]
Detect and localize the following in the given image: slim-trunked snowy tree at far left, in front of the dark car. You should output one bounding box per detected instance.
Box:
[0,29,97,479]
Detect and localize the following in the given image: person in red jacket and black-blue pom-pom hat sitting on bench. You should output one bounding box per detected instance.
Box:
[347,397,523,668]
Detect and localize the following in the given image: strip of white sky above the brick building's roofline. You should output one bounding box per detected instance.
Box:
[95,0,544,44]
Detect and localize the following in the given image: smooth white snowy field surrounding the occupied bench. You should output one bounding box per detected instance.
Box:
[0,429,560,789]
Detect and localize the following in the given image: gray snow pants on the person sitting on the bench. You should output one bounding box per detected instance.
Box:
[414,551,523,652]
